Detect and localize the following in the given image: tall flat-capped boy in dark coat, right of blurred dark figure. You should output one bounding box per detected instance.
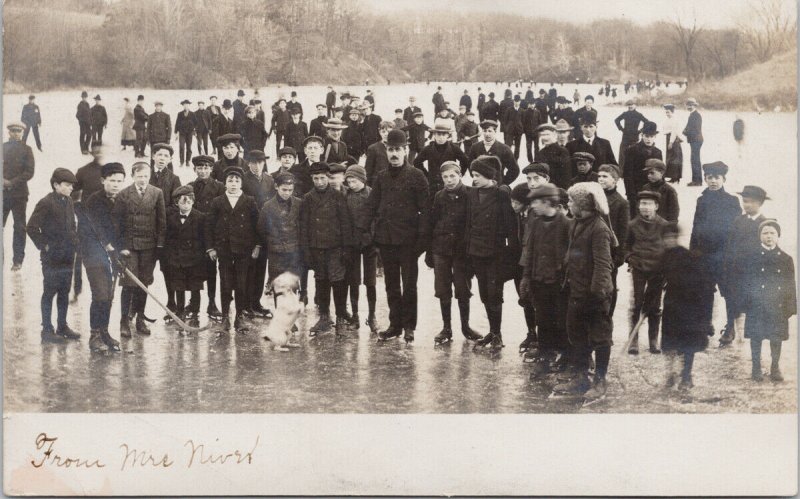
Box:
[689,161,742,342]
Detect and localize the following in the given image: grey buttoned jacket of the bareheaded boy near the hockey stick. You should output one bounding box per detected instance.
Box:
[112,184,167,251]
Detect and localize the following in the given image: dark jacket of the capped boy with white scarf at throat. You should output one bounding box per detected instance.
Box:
[206,193,261,258]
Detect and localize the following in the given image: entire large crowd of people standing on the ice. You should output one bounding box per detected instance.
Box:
[3,82,796,400]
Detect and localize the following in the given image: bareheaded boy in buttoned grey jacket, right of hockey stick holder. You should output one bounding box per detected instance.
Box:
[113,161,167,338]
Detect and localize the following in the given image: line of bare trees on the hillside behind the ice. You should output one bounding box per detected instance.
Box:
[3,0,797,90]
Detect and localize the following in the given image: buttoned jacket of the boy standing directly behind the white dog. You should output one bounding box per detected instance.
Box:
[258,196,303,253]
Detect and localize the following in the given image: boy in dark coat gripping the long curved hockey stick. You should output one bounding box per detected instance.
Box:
[77,163,125,352]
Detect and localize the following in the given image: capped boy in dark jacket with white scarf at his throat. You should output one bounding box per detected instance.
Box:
[205,166,261,333]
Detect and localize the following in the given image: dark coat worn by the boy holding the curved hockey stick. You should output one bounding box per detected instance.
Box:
[76,190,119,268]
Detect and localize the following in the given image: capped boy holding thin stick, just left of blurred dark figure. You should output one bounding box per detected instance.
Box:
[627,191,669,355]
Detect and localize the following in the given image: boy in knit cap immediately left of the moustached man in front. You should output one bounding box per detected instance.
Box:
[345,166,380,333]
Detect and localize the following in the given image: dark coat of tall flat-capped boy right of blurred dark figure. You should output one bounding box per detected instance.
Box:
[689,187,742,279]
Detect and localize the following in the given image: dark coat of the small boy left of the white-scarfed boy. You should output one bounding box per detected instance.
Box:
[166,206,208,270]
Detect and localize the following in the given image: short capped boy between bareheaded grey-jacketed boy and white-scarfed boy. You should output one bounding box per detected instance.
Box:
[165,185,207,327]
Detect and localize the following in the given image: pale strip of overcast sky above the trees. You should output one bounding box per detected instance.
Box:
[362,0,795,28]
